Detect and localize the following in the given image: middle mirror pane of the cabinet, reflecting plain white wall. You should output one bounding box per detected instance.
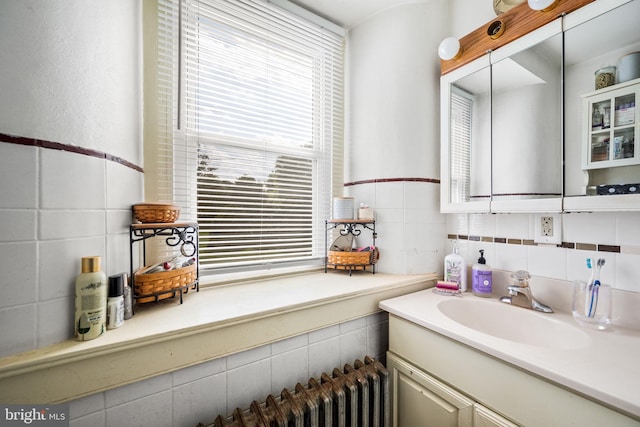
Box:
[491,33,562,203]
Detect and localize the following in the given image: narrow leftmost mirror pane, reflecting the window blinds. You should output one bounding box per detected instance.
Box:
[449,66,491,208]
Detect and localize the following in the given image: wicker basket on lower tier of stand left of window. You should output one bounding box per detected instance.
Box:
[134,264,197,303]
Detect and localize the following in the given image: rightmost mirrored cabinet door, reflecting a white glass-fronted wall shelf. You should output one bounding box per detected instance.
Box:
[564,0,640,211]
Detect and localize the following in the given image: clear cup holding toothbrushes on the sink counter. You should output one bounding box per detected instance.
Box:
[571,280,612,330]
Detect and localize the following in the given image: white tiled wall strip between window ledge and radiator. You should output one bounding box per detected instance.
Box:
[70,312,388,427]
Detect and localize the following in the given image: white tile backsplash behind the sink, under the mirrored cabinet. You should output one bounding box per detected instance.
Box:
[446,212,640,292]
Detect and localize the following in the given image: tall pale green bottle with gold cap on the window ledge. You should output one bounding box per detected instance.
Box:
[74,256,107,341]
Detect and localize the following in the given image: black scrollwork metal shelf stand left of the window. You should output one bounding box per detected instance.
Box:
[129,222,200,304]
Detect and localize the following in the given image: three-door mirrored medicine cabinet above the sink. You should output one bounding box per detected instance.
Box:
[441,0,640,213]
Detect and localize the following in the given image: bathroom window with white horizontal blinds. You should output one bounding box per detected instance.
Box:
[159,0,344,271]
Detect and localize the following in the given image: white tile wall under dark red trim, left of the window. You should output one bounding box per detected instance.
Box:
[0,143,143,357]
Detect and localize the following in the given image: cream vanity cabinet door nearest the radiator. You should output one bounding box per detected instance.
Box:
[387,353,474,427]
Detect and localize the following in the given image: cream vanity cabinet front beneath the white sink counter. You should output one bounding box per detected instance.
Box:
[387,314,639,427]
